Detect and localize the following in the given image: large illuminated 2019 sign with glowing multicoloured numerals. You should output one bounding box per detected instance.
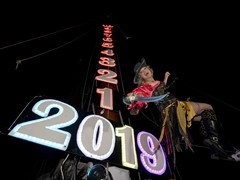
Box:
[9,99,166,175]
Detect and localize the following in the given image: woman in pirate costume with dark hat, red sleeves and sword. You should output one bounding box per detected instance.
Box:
[124,58,230,167]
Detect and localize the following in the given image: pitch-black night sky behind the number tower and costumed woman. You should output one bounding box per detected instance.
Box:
[0,3,240,179]
